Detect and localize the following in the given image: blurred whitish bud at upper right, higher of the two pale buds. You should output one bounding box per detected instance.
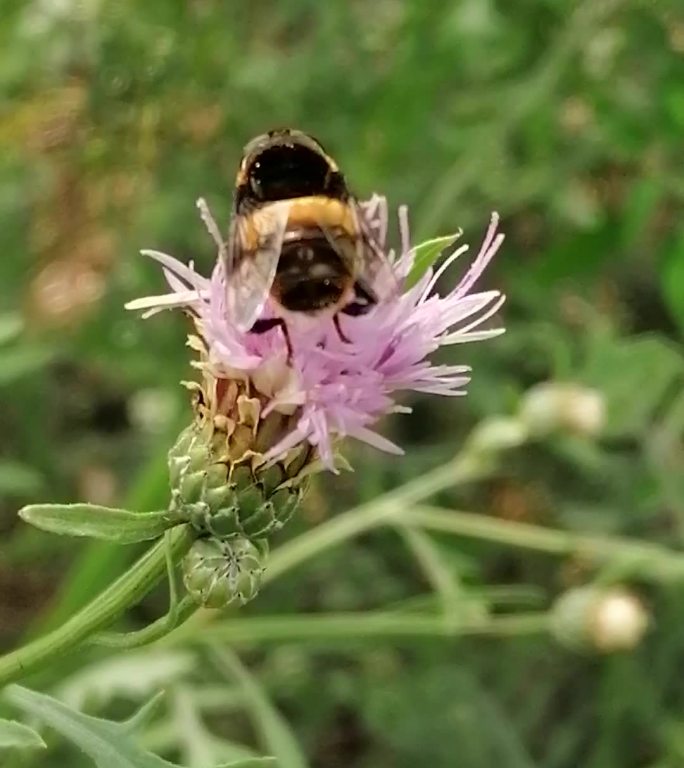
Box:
[520,382,606,437]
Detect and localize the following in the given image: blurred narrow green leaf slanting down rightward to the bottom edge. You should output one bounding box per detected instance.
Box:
[212,646,309,768]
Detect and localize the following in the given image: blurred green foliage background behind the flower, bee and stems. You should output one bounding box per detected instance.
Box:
[0,0,684,768]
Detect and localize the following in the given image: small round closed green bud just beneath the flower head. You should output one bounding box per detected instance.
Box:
[183,537,268,608]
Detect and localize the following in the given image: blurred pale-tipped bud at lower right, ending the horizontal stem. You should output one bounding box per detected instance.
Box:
[551,587,648,653]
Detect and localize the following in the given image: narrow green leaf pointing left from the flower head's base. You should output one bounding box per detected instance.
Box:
[19,504,171,544]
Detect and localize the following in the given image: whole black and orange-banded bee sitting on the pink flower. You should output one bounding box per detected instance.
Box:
[225,129,397,354]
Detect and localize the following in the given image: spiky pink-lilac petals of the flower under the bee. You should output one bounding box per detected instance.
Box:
[127,195,504,471]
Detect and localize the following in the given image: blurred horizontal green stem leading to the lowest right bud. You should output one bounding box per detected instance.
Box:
[168,611,549,646]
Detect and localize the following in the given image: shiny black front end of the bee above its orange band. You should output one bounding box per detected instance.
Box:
[236,128,348,210]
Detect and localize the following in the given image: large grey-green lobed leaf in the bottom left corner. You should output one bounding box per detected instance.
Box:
[5,685,273,768]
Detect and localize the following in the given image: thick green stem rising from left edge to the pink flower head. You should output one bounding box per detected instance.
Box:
[0,525,194,686]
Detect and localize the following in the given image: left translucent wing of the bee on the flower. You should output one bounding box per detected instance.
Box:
[226,202,290,331]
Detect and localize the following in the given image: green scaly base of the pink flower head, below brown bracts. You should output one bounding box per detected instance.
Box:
[169,424,303,539]
